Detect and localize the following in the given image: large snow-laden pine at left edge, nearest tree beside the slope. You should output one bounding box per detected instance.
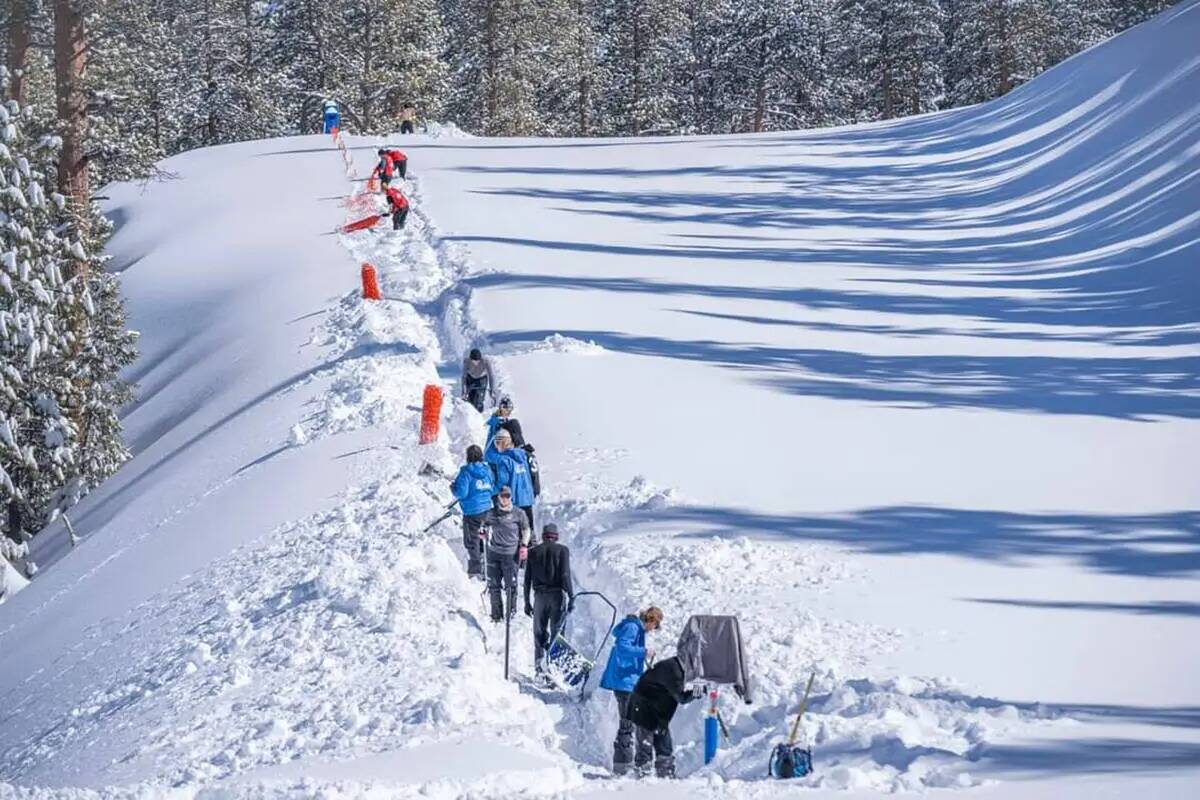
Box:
[0,71,136,544]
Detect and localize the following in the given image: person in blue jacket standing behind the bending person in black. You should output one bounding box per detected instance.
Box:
[600,606,662,775]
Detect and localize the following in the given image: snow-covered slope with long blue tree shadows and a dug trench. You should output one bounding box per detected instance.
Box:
[0,0,1200,798]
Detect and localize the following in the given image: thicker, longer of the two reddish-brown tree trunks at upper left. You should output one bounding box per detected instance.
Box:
[54,0,91,224]
